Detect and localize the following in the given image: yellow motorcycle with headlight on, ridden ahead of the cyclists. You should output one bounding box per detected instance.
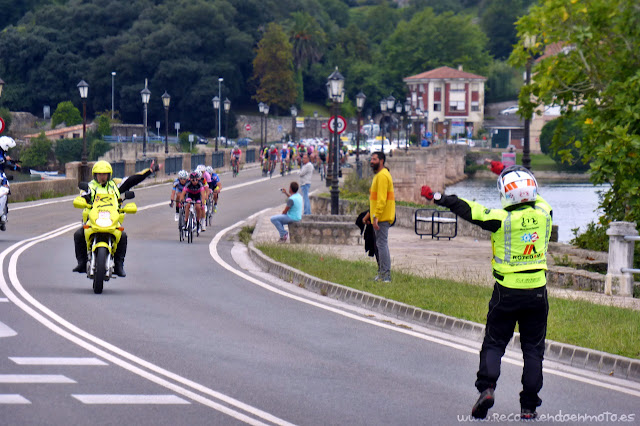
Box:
[73,191,138,294]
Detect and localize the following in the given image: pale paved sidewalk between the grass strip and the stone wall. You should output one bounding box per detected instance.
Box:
[252,204,640,310]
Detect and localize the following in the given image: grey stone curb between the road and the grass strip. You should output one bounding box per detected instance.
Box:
[248,241,640,383]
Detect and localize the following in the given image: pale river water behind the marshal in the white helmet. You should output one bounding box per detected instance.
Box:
[445,179,609,243]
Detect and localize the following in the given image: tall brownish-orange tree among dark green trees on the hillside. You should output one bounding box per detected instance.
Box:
[253,22,296,114]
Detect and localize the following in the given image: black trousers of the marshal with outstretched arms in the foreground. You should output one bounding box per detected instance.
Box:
[476,283,549,411]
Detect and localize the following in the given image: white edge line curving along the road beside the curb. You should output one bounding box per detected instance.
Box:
[209,216,640,398]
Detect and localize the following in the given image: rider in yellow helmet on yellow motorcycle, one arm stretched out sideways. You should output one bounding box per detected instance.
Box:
[73,160,160,277]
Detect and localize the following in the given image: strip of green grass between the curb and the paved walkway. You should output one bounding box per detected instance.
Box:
[257,244,640,358]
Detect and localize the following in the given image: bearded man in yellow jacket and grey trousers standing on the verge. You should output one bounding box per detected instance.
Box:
[364,152,396,283]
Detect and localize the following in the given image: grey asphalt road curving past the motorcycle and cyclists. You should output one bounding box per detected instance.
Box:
[0,166,640,425]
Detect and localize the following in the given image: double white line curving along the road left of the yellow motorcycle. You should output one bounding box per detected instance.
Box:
[0,223,291,425]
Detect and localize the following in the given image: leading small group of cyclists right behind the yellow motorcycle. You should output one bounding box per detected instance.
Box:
[169,164,222,232]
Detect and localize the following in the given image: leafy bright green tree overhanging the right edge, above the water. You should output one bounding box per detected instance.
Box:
[510,0,640,223]
